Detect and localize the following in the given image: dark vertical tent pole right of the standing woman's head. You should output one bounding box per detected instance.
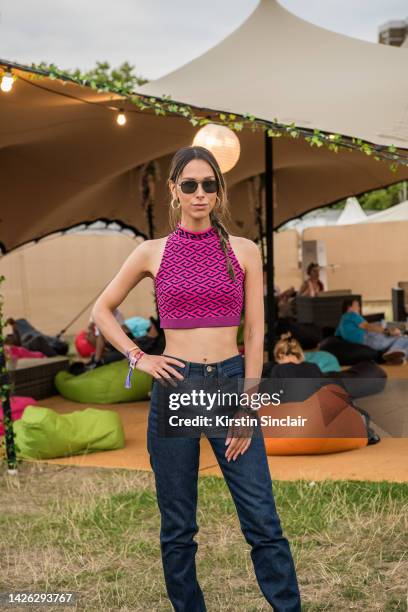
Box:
[265,132,275,361]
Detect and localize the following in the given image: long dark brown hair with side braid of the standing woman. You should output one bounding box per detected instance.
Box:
[167,146,236,280]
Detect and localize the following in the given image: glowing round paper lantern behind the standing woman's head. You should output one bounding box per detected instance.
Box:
[193,123,241,174]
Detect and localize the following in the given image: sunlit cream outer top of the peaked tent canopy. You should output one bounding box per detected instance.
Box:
[138,0,408,148]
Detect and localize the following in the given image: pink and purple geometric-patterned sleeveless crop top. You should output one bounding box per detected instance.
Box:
[154,223,245,329]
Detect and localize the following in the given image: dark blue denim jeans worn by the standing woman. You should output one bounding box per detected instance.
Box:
[147,355,301,612]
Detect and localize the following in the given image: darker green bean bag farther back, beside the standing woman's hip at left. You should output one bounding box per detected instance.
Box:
[54,359,153,404]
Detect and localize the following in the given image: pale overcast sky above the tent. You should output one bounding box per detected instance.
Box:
[0,0,408,80]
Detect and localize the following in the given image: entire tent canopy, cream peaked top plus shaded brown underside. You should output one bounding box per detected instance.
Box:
[0,0,408,252]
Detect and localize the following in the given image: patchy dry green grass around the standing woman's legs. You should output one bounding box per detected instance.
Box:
[0,462,408,612]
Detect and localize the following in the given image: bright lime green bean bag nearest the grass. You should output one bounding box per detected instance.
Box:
[13,406,125,459]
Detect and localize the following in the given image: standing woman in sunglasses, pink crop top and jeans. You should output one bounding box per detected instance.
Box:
[93,147,300,612]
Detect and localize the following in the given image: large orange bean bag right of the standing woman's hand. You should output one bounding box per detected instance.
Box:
[258,381,368,455]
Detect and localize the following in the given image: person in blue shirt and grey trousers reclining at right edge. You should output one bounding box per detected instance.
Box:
[335,298,408,365]
